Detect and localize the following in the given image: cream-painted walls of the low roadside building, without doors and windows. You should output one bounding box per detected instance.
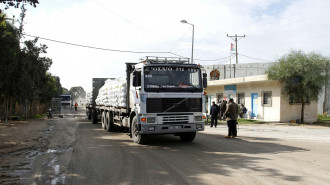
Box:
[206,81,317,123]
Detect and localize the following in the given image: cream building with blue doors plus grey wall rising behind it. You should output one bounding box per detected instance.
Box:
[204,63,326,123]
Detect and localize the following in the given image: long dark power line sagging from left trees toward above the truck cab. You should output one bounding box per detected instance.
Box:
[23,34,174,54]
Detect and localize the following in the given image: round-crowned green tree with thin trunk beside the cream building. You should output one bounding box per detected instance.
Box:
[266,50,327,123]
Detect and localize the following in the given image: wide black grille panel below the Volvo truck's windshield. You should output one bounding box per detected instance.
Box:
[147,98,202,113]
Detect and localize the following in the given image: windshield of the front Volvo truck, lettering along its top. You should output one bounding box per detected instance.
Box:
[144,66,203,92]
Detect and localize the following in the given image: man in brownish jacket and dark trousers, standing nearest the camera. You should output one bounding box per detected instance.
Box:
[225,98,238,138]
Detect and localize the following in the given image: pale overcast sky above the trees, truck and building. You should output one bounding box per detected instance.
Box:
[1,0,330,91]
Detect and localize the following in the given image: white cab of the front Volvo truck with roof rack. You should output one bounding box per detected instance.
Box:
[126,57,207,143]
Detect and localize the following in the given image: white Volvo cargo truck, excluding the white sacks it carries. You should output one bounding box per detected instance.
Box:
[86,57,207,144]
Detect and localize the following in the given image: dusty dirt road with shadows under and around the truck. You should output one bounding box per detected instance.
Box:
[1,107,330,184]
